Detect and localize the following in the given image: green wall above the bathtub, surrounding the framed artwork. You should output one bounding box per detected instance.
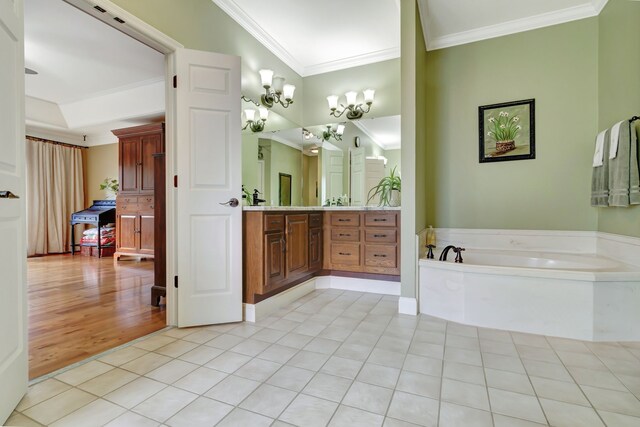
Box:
[424,18,600,230]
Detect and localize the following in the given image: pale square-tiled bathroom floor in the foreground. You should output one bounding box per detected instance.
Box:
[8,290,640,427]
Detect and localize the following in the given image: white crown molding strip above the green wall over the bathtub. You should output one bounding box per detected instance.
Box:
[419,0,608,51]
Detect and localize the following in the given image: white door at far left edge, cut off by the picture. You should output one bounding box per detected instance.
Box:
[0,0,29,425]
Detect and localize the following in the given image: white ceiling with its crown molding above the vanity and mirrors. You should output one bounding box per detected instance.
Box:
[213,0,400,77]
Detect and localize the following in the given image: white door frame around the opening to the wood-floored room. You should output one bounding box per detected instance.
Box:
[64,0,184,326]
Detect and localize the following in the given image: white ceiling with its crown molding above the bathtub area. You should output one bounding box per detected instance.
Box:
[418,0,608,50]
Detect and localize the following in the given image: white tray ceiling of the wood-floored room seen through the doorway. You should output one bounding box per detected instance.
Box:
[25,0,165,145]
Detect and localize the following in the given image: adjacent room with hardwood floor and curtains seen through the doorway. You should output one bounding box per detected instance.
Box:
[25,0,166,378]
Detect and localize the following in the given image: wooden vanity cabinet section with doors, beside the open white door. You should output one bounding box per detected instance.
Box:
[243,211,323,304]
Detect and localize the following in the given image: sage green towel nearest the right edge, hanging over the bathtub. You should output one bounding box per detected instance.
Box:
[609,121,640,207]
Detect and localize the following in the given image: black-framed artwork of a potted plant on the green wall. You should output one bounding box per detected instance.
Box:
[478,99,536,163]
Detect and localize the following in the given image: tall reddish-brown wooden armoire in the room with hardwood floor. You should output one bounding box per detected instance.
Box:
[112,123,164,259]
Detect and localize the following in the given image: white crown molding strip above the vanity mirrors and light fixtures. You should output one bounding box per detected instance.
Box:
[212,0,400,77]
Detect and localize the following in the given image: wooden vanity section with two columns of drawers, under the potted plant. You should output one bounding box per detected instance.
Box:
[324,211,400,276]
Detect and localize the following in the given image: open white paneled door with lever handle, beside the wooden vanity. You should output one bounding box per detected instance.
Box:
[176,49,242,327]
